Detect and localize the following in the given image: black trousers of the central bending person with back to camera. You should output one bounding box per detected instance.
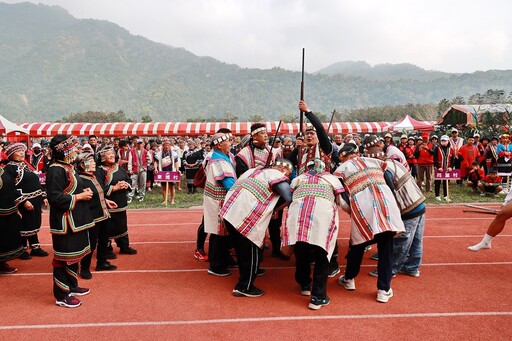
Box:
[294,242,330,298]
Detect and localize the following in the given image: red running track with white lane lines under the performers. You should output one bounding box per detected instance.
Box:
[0,205,512,340]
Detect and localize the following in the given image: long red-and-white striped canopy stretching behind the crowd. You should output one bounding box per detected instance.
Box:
[14,122,392,137]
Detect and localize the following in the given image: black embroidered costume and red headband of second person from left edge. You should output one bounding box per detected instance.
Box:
[5,143,48,258]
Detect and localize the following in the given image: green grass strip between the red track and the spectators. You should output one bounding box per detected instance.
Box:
[129,179,505,208]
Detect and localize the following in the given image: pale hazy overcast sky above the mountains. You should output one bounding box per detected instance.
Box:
[4,0,512,72]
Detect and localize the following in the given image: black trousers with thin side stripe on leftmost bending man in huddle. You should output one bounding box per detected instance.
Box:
[224,220,261,290]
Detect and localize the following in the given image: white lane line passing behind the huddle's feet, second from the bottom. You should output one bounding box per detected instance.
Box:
[6,262,512,277]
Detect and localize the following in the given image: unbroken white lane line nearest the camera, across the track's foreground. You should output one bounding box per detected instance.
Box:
[0,311,512,330]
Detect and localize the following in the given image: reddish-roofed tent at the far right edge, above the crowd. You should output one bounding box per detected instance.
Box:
[437,104,512,127]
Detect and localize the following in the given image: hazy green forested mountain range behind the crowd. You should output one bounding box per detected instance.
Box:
[0,3,512,122]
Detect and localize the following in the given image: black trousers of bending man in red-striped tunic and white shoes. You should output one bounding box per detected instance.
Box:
[345,231,395,291]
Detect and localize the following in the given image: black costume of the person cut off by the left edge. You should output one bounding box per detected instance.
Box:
[0,167,24,273]
